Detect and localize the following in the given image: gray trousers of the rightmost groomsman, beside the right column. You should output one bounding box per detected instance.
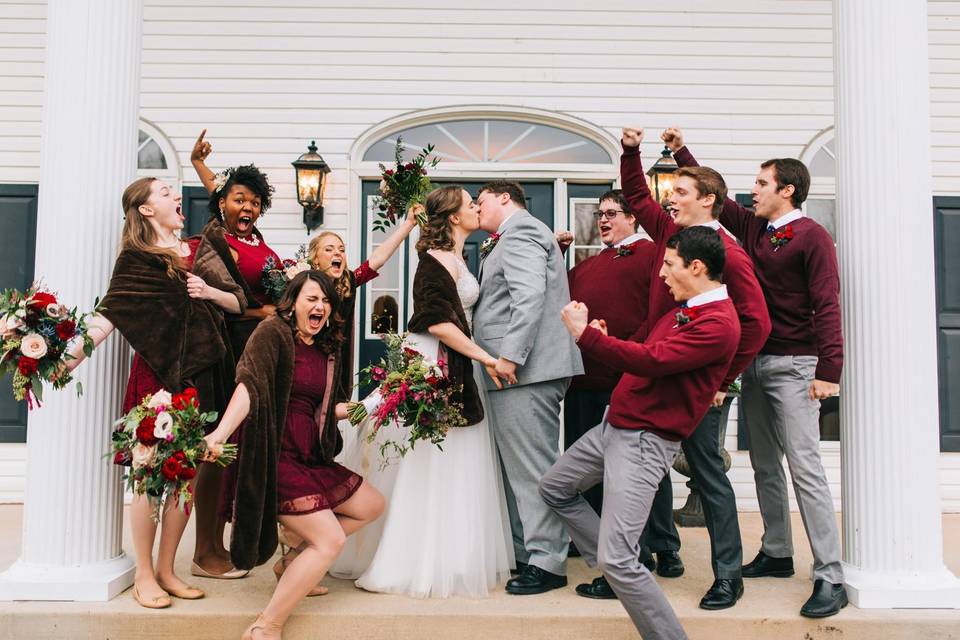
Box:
[742,355,843,584]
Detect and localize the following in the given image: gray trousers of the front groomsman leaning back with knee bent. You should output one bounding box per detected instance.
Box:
[540,416,687,640]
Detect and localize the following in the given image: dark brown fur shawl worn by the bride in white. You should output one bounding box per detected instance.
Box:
[407,251,483,425]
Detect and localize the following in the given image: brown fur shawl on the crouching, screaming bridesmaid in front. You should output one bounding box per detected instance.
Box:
[230,316,345,569]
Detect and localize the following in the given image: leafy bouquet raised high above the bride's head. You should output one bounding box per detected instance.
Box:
[373,137,440,231]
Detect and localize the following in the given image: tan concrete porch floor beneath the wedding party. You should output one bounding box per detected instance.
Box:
[0,505,960,640]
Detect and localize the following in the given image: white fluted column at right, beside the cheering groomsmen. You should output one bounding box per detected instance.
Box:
[833,0,960,608]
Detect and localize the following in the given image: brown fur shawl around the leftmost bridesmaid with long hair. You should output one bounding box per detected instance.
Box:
[100,249,233,402]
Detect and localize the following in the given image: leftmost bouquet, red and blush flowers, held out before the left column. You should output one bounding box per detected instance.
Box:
[0,284,96,409]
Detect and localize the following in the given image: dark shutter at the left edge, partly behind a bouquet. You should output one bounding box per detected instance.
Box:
[0,184,38,442]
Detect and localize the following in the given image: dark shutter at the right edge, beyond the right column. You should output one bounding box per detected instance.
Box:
[933,197,960,451]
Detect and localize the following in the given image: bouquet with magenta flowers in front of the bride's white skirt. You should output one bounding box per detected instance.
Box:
[349,333,467,459]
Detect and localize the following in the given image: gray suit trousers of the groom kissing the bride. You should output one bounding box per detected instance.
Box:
[487,378,570,575]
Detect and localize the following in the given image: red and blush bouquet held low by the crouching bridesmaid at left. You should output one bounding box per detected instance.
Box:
[108,387,237,522]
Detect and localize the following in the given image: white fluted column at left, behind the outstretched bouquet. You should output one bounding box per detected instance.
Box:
[0,0,143,600]
